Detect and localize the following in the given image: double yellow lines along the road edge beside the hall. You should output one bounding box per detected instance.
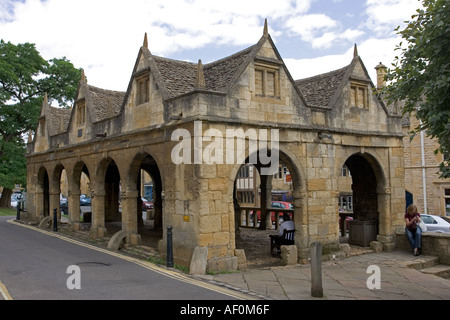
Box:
[7,220,257,300]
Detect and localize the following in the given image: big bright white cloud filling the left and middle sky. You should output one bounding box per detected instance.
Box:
[0,0,312,90]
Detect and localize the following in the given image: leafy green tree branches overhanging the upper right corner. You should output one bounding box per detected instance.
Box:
[385,0,450,178]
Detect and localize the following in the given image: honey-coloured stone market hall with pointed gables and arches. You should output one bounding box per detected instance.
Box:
[27,21,405,271]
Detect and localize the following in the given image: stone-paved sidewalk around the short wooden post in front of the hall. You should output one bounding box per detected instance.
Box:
[196,251,450,300]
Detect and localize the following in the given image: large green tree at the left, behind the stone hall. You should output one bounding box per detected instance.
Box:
[0,40,81,207]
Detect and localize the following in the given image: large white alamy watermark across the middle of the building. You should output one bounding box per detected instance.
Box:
[171,121,280,175]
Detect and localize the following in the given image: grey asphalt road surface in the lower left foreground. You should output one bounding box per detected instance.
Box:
[0,217,248,300]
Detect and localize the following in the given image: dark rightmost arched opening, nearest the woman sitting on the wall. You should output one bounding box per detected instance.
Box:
[339,154,385,246]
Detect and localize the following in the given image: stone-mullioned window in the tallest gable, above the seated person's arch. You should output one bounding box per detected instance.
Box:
[255,64,280,98]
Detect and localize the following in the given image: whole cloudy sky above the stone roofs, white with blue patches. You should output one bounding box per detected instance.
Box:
[0,0,421,91]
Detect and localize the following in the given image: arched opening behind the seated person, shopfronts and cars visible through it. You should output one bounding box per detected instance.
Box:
[233,152,302,268]
